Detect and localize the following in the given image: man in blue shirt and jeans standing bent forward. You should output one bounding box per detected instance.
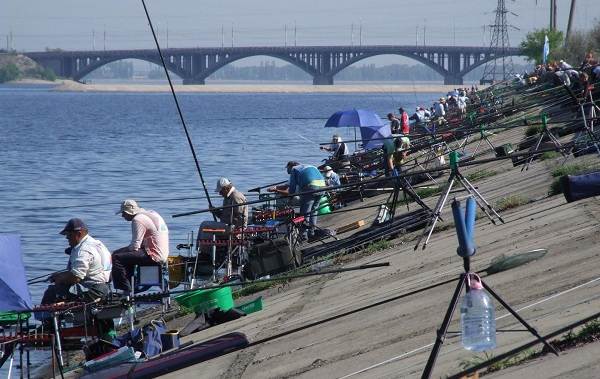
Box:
[268,161,325,238]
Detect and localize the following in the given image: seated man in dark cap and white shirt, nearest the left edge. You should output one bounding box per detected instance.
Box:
[42,218,111,304]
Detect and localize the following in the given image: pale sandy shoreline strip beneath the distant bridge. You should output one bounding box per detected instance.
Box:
[2,79,476,94]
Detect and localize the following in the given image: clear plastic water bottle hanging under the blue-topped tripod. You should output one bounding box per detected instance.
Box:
[460,274,496,351]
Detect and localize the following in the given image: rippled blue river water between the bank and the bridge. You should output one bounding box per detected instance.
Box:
[0,86,440,303]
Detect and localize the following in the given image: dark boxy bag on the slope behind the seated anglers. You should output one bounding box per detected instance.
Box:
[249,238,299,278]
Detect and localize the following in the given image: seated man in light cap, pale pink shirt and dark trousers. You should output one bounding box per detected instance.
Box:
[112,199,169,294]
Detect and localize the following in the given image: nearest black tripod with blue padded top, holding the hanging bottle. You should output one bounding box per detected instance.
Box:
[421,198,558,379]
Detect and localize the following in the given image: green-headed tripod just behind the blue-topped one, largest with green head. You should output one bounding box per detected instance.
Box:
[415,151,504,250]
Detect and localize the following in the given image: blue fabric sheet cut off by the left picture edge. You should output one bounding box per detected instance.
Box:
[0,234,33,312]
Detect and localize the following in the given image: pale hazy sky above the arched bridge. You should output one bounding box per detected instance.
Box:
[0,0,600,67]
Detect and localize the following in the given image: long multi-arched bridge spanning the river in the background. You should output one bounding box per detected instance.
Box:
[25,45,521,85]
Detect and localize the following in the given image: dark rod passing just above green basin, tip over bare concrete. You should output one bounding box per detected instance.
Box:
[131,262,390,301]
